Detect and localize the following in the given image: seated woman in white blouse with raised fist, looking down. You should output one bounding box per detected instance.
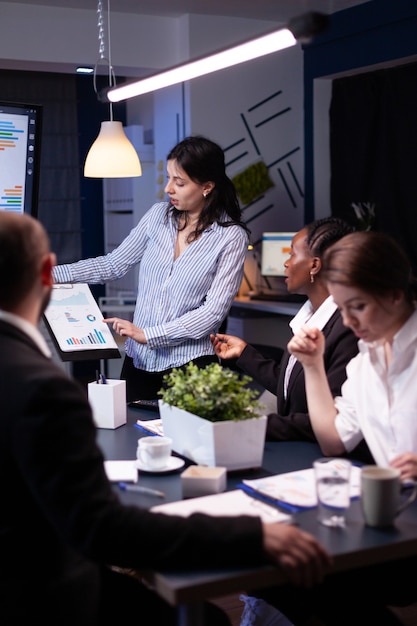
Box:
[288,231,417,479]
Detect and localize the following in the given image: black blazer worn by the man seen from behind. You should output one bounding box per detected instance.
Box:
[0,320,265,626]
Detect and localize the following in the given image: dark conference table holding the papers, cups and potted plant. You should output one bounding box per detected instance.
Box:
[98,408,417,626]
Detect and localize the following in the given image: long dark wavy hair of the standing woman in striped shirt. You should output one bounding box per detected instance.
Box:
[167,135,250,241]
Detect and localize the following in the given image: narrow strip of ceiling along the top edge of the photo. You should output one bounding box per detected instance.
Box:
[10,0,369,23]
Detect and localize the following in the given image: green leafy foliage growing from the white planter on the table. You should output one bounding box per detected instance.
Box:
[159,363,260,422]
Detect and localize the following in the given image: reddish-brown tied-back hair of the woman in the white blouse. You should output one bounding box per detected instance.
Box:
[323,231,417,302]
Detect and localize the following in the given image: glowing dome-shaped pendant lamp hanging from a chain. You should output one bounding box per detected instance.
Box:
[84,0,142,178]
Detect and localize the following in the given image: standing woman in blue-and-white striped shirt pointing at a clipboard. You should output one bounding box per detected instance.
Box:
[54,136,249,401]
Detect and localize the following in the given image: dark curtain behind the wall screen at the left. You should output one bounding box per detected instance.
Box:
[0,70,81,263]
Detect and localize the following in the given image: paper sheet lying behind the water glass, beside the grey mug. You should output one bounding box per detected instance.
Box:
[241,465,361,511]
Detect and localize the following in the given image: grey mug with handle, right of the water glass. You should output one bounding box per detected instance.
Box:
[361,465,417,526]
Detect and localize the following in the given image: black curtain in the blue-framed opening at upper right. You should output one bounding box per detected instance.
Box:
[330,63,417,274]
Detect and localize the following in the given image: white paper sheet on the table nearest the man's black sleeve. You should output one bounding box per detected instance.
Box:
[152,489,292,522]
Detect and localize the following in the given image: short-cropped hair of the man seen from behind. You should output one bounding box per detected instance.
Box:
[0,211,49,311]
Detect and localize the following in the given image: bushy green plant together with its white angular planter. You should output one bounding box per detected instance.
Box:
[159,363,266,470]
